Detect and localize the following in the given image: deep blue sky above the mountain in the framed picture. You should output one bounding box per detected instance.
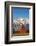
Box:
[11,7,29,19]
